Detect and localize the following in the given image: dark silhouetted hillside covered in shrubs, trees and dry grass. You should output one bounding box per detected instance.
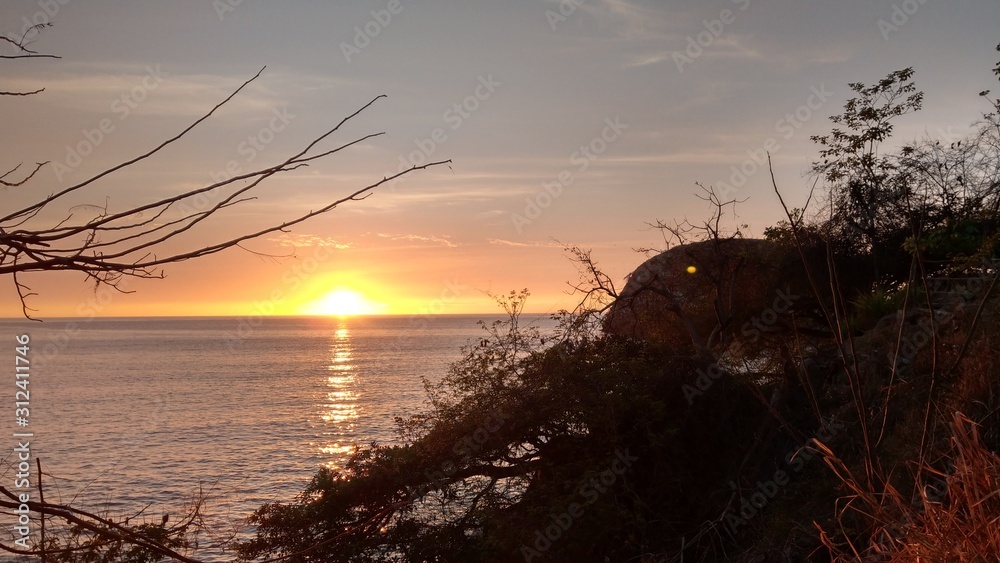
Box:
[239,45,1000,562]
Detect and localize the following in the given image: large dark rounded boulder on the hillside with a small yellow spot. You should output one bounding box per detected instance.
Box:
[604,238,801,352]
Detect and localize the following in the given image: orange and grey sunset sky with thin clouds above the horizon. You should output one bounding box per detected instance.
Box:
[0,0,1000,319]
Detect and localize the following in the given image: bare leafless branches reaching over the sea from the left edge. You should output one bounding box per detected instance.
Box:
[0,68,451,318]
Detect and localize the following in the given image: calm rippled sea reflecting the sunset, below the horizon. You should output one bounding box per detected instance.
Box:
[0,315,550,561]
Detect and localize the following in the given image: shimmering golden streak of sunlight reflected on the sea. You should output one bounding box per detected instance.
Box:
[320,320,360,469]
